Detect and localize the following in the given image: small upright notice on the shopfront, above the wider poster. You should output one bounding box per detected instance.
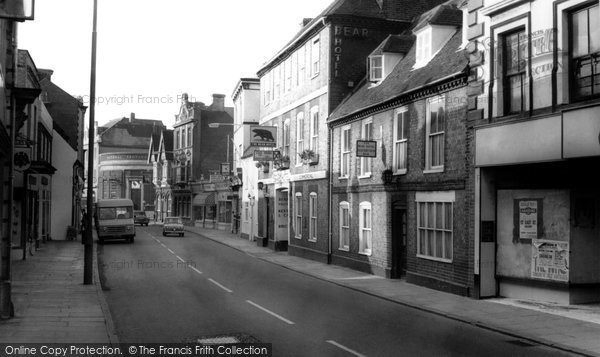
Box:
[514,199,543,242]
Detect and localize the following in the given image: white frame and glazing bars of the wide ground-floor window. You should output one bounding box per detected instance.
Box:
[415,191,456,263]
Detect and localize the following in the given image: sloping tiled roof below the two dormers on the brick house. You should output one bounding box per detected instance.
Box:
[328,31,468,122]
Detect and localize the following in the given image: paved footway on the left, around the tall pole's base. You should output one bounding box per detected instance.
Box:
[0,237,118,345]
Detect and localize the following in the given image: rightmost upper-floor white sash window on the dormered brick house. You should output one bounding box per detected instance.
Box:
[425,96,446,171]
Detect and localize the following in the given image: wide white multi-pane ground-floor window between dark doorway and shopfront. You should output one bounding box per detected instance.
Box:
[416,191,455,262]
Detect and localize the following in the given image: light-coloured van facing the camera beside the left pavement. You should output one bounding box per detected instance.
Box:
[94,198,135,243]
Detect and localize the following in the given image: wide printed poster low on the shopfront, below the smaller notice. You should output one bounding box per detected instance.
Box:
[531,239,569,282]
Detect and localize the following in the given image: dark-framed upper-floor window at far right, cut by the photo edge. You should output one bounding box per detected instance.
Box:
[570,3,600,100]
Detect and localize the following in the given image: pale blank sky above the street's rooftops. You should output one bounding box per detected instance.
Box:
[18,0,332,127]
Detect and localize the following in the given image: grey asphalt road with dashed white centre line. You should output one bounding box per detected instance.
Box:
[98,226,567,356]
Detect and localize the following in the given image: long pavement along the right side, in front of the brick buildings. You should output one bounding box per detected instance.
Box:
[186,227,600,356]
